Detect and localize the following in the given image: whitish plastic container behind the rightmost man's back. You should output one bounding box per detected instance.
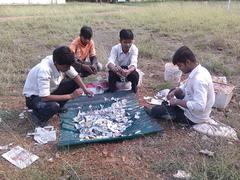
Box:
[213,82,235,109]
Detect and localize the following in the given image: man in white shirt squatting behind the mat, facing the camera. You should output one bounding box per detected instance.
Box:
[106,29,139,93]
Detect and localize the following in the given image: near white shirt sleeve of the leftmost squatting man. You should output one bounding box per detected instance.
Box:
[37,70,51,97]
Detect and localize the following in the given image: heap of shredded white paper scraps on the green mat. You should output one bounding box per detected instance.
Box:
[73,99,133,140]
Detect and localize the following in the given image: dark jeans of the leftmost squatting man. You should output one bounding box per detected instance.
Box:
[26,79,78,121]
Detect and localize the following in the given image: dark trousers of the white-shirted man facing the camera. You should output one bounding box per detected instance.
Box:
[108,66,139,93]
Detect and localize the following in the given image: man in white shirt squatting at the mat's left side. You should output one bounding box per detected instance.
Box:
[23,46,92,126]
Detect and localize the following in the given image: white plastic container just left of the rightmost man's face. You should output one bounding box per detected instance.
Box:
[164,63,182,86]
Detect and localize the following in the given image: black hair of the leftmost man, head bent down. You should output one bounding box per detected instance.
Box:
[53,46,75,65]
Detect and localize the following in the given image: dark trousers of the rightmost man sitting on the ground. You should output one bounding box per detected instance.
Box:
[150,102,196,125]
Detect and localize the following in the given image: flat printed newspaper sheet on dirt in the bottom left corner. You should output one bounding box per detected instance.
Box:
[2,146,39,169]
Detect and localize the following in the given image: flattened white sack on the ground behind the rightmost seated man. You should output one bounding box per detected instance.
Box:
[193,119,239,140]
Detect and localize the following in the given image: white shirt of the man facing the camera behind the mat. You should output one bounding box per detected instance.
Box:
[106,43,138,69]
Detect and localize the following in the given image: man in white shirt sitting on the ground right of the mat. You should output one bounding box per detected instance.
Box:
[145,46,215,125]
